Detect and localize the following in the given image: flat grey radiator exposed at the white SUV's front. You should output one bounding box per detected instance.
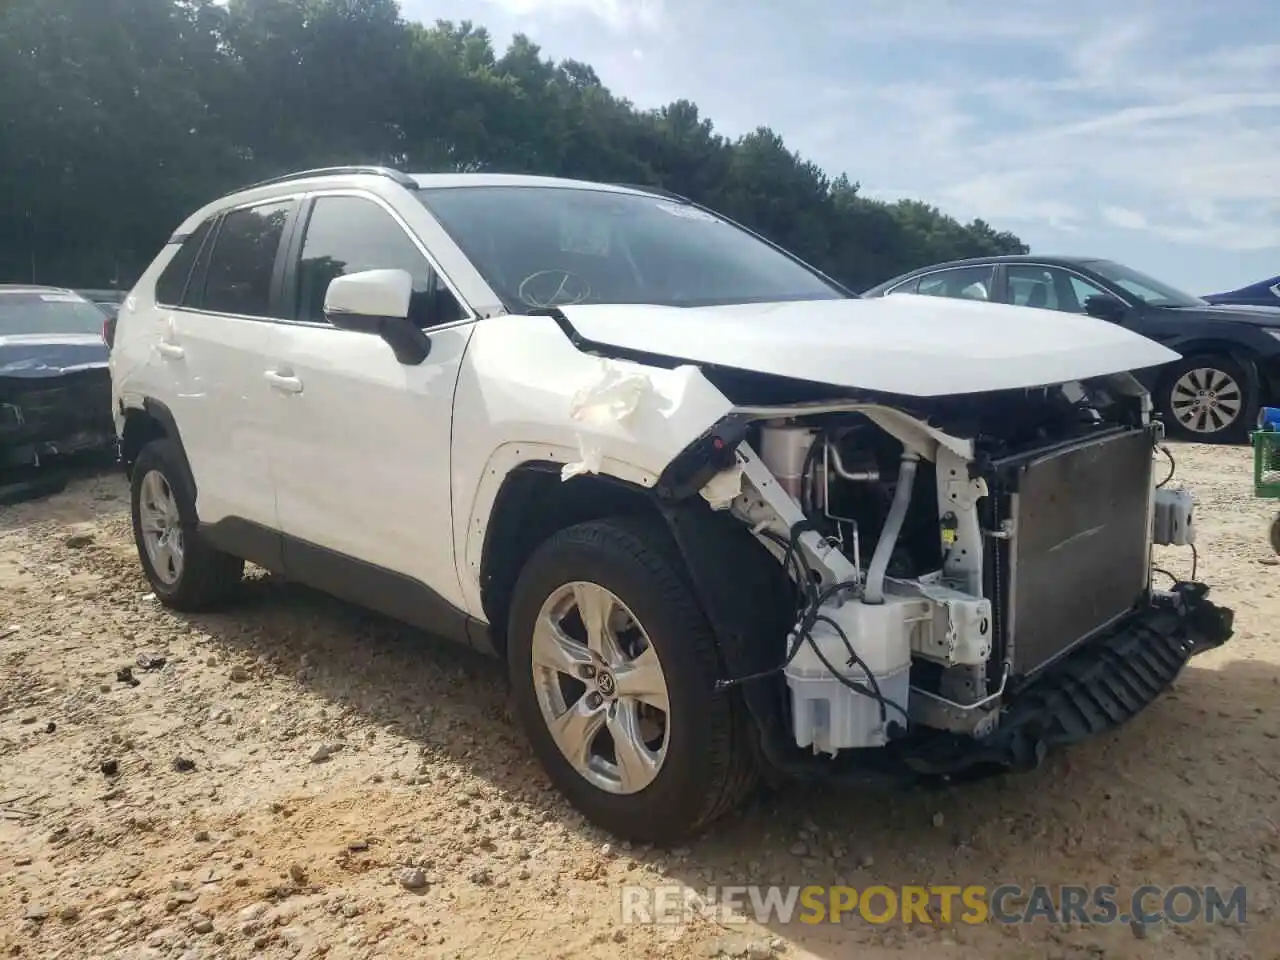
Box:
[983,430,1153,678]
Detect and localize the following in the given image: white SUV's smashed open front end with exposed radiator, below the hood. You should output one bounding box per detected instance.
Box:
[655,374,1233,778]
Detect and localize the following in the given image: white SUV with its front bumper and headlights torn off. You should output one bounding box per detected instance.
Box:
[111,168,1231,842]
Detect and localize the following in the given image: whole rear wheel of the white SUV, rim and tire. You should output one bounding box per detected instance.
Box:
[131,439,244,611]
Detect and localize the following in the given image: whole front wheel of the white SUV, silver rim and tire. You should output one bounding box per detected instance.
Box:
[507,520,755,845]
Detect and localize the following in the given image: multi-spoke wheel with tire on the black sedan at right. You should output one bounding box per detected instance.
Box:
[1157,356,1258,443]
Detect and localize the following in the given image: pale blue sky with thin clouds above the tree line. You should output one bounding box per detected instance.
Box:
[402,0,1280,294]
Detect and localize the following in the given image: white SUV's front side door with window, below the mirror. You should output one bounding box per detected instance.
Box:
[264,195,474,609]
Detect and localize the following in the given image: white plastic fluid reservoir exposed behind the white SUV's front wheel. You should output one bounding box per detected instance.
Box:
[783,596,929,756]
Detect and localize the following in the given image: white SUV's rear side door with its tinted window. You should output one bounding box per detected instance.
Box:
[154,198,298,535]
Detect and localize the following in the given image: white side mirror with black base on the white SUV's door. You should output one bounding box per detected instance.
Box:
[324,270,431,366]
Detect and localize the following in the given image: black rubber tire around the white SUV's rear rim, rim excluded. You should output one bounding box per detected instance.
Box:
[129,438,244,612]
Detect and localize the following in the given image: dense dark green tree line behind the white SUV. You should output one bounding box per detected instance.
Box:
[0,0,1027,289]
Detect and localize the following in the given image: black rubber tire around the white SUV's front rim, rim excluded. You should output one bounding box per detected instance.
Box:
[507,518,756,845]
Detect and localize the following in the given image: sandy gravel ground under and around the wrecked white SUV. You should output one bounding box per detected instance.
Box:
[0,445,1280,960]
